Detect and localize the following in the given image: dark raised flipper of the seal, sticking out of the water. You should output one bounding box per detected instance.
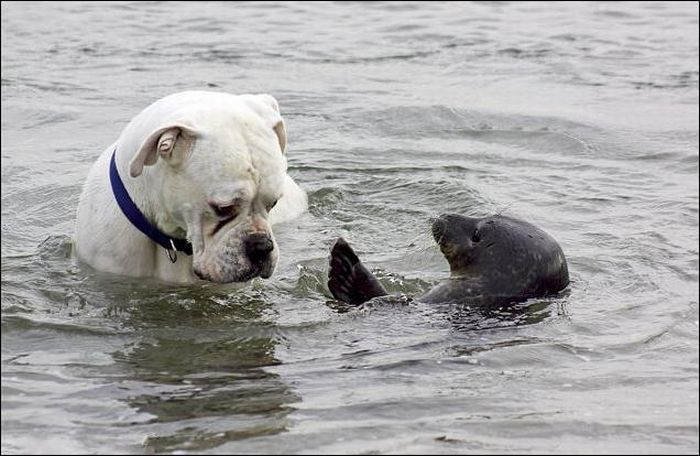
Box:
[328,238,389,304]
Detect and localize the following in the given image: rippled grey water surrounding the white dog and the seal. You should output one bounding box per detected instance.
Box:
[2,2,699,454]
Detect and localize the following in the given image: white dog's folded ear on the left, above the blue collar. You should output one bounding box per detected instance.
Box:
[129,124,197,177]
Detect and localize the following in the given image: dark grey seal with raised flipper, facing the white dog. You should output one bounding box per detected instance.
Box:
[328,214,569,307]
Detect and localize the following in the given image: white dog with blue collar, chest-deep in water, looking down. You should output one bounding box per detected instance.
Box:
[74,91,307,282]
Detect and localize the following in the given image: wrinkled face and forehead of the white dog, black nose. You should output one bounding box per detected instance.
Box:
[132,95,287,282]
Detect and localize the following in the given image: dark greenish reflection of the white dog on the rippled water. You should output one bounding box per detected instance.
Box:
[108,286,299,452]
